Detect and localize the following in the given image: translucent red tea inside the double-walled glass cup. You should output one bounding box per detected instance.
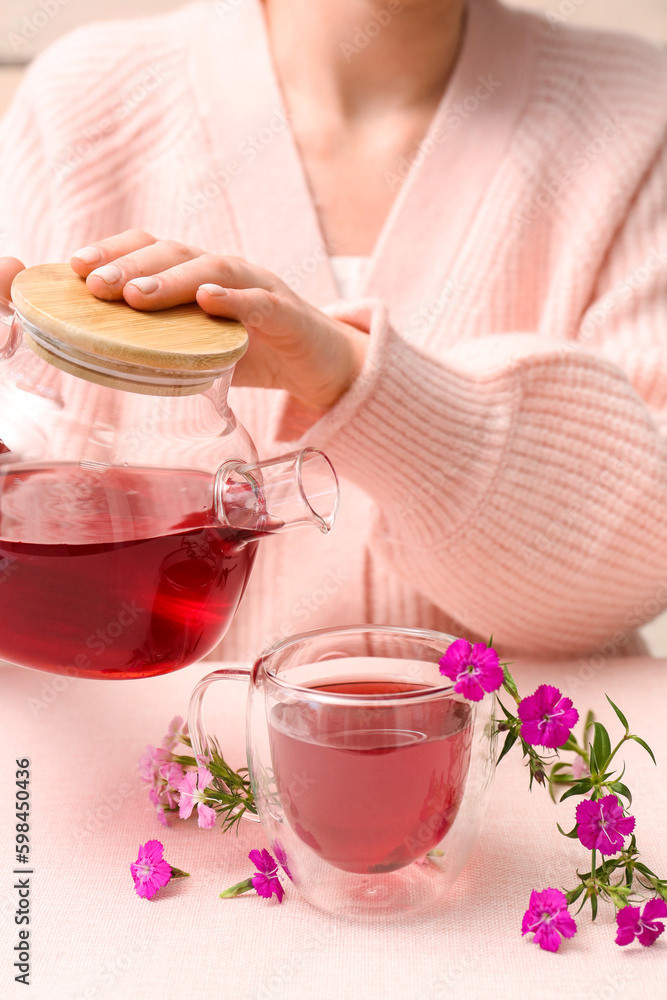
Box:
[269,676,472,874]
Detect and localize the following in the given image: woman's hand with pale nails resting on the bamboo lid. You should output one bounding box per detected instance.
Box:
[71,229,368,409]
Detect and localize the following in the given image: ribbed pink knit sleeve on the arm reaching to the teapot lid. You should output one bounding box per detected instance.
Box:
[284,141,667,654]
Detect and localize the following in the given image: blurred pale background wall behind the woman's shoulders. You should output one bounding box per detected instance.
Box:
[0,0,667,656]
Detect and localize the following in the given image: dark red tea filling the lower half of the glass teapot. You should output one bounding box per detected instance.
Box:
[0,466,261,680]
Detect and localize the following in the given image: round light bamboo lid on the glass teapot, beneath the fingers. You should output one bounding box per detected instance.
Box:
[12,264,248,396]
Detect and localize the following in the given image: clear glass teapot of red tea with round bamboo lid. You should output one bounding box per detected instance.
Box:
[0,264,339,679]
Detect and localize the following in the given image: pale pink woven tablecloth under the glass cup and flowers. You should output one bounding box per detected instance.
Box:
[0,659,667,1000]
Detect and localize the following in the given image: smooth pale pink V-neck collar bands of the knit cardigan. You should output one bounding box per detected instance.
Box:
[191,0,531,335]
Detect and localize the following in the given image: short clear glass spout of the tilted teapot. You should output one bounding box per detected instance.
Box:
[214,448,340,534]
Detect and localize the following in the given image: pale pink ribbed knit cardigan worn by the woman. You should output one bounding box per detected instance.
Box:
[0,0,667,658]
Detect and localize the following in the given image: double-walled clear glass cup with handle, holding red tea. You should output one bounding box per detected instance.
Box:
[189,625,496,918]
